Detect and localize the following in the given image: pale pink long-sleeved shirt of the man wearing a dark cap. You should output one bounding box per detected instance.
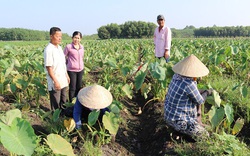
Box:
[154,26,172,57]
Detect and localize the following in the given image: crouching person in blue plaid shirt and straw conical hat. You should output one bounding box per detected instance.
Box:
[164,55,212,137]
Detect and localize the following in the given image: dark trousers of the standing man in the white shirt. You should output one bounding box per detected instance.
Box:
[49,87,67,111]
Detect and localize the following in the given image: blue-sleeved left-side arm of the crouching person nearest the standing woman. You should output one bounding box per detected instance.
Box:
[73,99,83,129]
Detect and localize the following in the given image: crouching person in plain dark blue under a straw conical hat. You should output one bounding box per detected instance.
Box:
[73,84,113,129]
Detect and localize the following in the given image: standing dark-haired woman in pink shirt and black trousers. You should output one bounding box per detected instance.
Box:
[64,31,84,102]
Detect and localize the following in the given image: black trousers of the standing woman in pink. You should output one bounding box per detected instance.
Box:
[68,70,84,102]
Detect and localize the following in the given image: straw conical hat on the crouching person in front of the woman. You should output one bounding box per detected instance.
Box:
[77,84,113,109]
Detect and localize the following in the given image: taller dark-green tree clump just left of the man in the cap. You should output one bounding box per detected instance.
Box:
[97,21,157,39]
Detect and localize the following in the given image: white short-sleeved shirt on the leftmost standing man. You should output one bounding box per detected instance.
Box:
[44,43,68,91]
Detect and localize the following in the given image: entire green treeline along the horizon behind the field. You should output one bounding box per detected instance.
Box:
[0,24,250,41]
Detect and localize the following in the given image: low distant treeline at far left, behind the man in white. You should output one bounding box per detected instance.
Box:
[0,28,70,41]
